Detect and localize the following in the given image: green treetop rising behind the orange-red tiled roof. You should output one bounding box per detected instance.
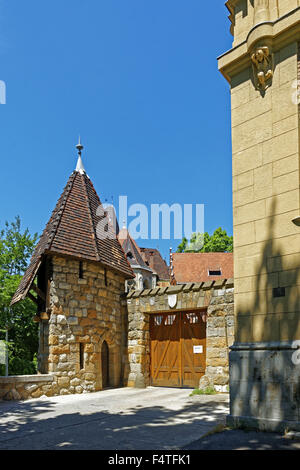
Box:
[177,227,233,253]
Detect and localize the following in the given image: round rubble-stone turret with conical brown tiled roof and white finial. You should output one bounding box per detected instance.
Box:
[12,143,134,396]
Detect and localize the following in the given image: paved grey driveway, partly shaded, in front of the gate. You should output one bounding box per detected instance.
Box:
[0,387,228,450]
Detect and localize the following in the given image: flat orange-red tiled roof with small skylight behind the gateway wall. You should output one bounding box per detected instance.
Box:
[172,253,233,284]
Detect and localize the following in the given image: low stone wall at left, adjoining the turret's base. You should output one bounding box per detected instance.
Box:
[0,374,54,400]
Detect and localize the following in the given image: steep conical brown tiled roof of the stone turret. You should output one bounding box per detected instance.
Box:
[11,171,134,304]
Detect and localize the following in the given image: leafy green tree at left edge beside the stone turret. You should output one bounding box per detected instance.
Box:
[0,217,38,375]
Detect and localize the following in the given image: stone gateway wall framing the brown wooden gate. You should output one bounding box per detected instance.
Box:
[125,279,234,391]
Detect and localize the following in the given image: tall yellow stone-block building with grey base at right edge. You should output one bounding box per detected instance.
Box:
[219,0,300,429]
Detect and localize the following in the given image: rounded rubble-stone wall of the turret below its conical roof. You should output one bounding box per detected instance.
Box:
[39,256,126,395]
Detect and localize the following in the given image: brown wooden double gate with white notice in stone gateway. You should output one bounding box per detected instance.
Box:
[150,311,206,388]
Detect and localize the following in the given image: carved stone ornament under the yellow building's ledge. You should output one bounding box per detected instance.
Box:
[251,46,274,92]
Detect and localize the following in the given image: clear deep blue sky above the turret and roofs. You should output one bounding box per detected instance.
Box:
[0,0,232,260]
